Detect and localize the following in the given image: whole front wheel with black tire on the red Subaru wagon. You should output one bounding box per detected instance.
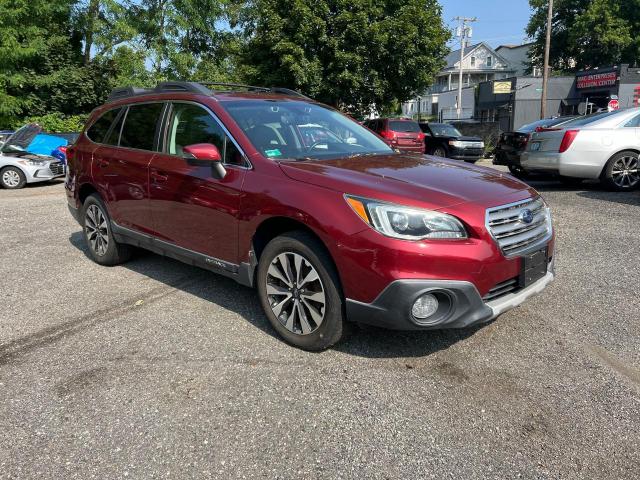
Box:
[257,232,350,351]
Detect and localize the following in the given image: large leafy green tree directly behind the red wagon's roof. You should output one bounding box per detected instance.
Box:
[232,0,450,114]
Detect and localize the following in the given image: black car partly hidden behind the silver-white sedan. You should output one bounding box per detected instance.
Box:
[493,116,575,178]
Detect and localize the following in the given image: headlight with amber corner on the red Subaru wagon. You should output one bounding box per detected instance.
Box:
[345,195,467,240]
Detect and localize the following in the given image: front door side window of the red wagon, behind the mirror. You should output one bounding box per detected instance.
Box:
[167,103,244,165]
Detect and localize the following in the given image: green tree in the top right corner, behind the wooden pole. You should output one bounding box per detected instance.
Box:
[527,0,640,72]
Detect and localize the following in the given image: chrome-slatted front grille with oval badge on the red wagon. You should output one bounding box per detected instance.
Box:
[486,197,551,257]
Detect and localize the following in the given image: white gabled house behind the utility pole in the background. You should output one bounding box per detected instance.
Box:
[402,42,531,120]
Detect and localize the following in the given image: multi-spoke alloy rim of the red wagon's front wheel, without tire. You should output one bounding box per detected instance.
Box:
[267,252,326,335]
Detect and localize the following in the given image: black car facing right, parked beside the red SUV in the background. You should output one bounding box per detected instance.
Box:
[420,123,484,163]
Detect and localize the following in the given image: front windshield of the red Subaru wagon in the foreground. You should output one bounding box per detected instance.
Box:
[222,100,394,160]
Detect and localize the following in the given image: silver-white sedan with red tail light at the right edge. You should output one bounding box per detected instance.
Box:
[521,108,640,191]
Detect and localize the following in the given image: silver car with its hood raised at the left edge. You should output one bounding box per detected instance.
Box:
[0,124,65,189]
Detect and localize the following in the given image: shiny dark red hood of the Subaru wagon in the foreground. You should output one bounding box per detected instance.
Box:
[280,154,536,209]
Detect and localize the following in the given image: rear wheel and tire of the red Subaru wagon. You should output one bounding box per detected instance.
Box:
[81,194,133,267]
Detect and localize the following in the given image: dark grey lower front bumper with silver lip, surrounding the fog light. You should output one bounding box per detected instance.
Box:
[346,260,555,330]
